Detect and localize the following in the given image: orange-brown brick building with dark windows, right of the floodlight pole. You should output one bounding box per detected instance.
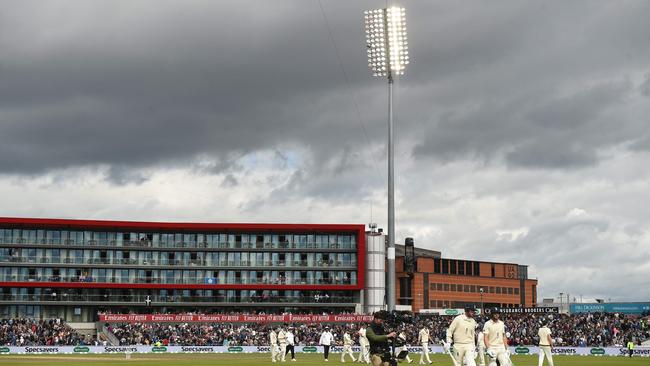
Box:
[396,249,537,312]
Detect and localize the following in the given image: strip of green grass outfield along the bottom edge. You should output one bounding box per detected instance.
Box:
[0,353,650,366]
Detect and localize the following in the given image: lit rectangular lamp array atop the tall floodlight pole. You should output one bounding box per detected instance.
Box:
[365,7,409,76]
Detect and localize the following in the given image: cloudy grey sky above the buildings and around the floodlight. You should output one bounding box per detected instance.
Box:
[0,0,650,300]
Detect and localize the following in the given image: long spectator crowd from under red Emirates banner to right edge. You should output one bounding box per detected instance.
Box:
[109,313,650,347]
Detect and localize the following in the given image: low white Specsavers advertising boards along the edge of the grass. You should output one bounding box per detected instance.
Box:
[0,346,650,357]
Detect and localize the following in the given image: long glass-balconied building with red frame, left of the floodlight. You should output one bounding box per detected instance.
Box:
[0,218,366,322]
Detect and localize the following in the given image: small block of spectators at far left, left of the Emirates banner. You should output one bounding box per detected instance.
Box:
[0,319,87,346]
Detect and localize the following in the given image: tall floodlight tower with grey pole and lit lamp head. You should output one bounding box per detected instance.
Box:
[365,6,409,311]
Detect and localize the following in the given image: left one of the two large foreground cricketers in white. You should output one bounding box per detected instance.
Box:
[443,306,476,366]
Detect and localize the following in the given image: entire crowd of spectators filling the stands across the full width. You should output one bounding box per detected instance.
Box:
[0,313,650,347]
